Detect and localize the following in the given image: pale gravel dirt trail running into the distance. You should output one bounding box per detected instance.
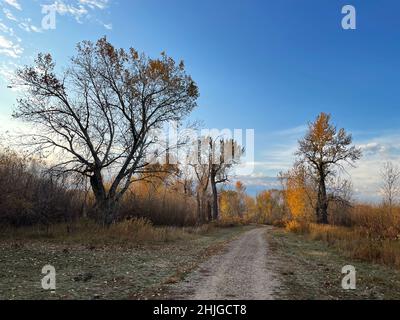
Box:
[171,227,279,300]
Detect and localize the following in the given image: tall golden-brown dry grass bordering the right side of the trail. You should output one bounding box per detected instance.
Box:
[286,204,400,269]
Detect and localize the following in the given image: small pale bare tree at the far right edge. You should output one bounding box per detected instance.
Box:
[381,161,400,214]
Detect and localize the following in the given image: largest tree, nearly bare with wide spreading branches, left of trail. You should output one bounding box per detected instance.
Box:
[14,38,199,224]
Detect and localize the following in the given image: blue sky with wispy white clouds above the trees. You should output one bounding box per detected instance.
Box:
[0,0,400,199]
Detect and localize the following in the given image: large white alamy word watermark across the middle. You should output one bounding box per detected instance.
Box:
[146,121,255,175]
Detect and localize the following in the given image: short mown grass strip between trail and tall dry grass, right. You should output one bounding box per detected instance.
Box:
[266,229,400,300]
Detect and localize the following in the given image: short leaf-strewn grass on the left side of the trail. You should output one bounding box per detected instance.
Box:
[0,227,253,300]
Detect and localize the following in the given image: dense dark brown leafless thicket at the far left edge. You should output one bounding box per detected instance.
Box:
[0,150,81,227]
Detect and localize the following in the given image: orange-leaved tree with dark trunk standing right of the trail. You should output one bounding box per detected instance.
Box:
[296,113,361,224]
